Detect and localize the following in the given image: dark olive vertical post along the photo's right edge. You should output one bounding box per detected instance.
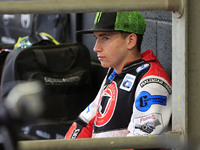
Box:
[188,0,200,146]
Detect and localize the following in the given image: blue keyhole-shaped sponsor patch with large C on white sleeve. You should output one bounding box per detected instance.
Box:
[135,91,167,111]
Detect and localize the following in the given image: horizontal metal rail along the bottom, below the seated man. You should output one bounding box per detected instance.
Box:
[18,132,183,150]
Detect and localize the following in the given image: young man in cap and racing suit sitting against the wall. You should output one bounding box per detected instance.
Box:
[65,11,172,139]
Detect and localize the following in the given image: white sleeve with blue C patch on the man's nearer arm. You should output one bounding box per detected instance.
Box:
[128,76,172,136]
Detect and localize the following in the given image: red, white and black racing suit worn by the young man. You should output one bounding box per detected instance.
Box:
[65,50,172,139]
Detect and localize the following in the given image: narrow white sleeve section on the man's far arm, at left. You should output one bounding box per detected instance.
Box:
[79,77,107,123]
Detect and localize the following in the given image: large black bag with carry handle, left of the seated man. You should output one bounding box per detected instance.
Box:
[1,44,91,120]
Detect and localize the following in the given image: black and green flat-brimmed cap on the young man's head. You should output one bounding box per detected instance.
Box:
[78,11,146,35]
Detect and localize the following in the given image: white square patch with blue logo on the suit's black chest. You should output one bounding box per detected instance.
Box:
[120,74,135,92]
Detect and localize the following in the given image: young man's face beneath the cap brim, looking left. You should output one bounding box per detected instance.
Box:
[94,32,129,72]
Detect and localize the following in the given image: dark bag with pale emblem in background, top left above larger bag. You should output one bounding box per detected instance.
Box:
[0,14,71,44]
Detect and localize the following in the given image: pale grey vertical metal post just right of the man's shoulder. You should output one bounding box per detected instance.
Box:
[172,0,188,148]
